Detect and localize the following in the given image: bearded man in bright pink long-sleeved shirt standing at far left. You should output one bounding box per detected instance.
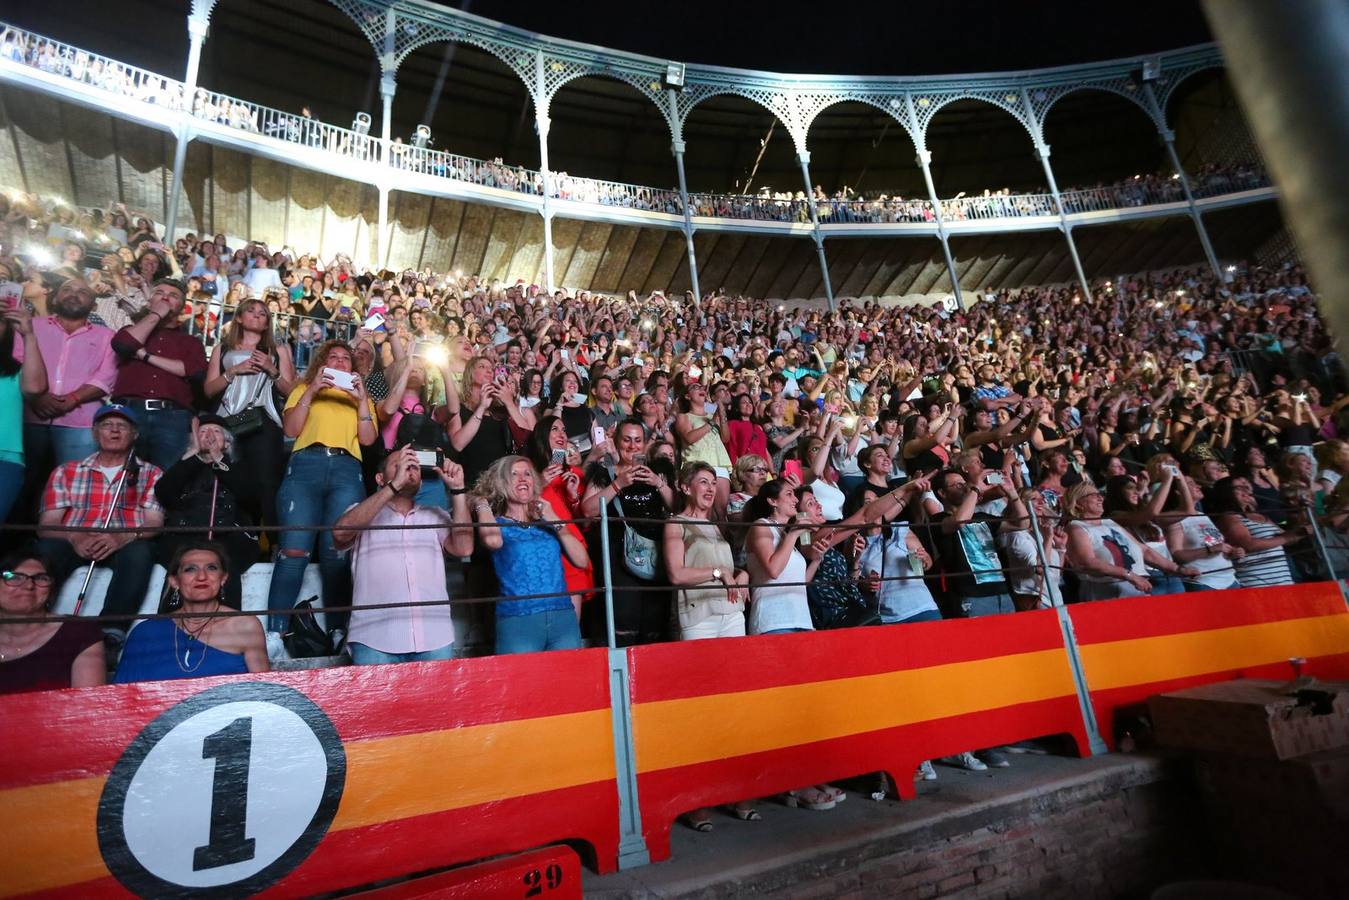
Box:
[23,279,117,464]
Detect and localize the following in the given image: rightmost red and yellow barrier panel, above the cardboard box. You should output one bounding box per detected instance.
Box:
[1068,582,1349,748]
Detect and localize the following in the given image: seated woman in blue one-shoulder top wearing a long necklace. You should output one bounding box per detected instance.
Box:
[113,541,271,684]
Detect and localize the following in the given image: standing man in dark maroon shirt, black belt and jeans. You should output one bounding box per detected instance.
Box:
[112,278,206,468]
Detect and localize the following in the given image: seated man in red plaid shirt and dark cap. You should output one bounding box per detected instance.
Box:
[36,403,165,645]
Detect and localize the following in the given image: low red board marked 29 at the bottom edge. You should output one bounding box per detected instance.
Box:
[348,847,581,900]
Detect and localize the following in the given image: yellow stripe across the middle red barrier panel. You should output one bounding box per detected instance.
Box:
[633,650,1074,772]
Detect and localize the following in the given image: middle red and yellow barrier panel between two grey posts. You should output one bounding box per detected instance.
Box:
[629,610,1087,860]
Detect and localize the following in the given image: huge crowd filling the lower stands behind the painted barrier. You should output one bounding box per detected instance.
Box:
[0,183,1349,701]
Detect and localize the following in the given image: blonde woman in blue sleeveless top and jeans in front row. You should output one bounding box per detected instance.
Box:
[473,456,590,653]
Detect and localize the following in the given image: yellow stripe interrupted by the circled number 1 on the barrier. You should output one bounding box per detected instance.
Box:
[0,710,614,897]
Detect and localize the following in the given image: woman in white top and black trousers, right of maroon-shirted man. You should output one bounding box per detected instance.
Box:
[202,300,295,512]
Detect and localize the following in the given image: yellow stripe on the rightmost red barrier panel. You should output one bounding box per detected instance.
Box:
[1082,615,1349,691]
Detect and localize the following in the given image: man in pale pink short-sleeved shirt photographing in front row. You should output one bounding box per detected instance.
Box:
[329,447,473,665]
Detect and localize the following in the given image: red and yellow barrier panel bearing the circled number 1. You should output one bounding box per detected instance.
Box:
[0,650,618,897]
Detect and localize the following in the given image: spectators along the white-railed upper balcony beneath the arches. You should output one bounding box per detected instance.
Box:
[0,27,1269,224]
